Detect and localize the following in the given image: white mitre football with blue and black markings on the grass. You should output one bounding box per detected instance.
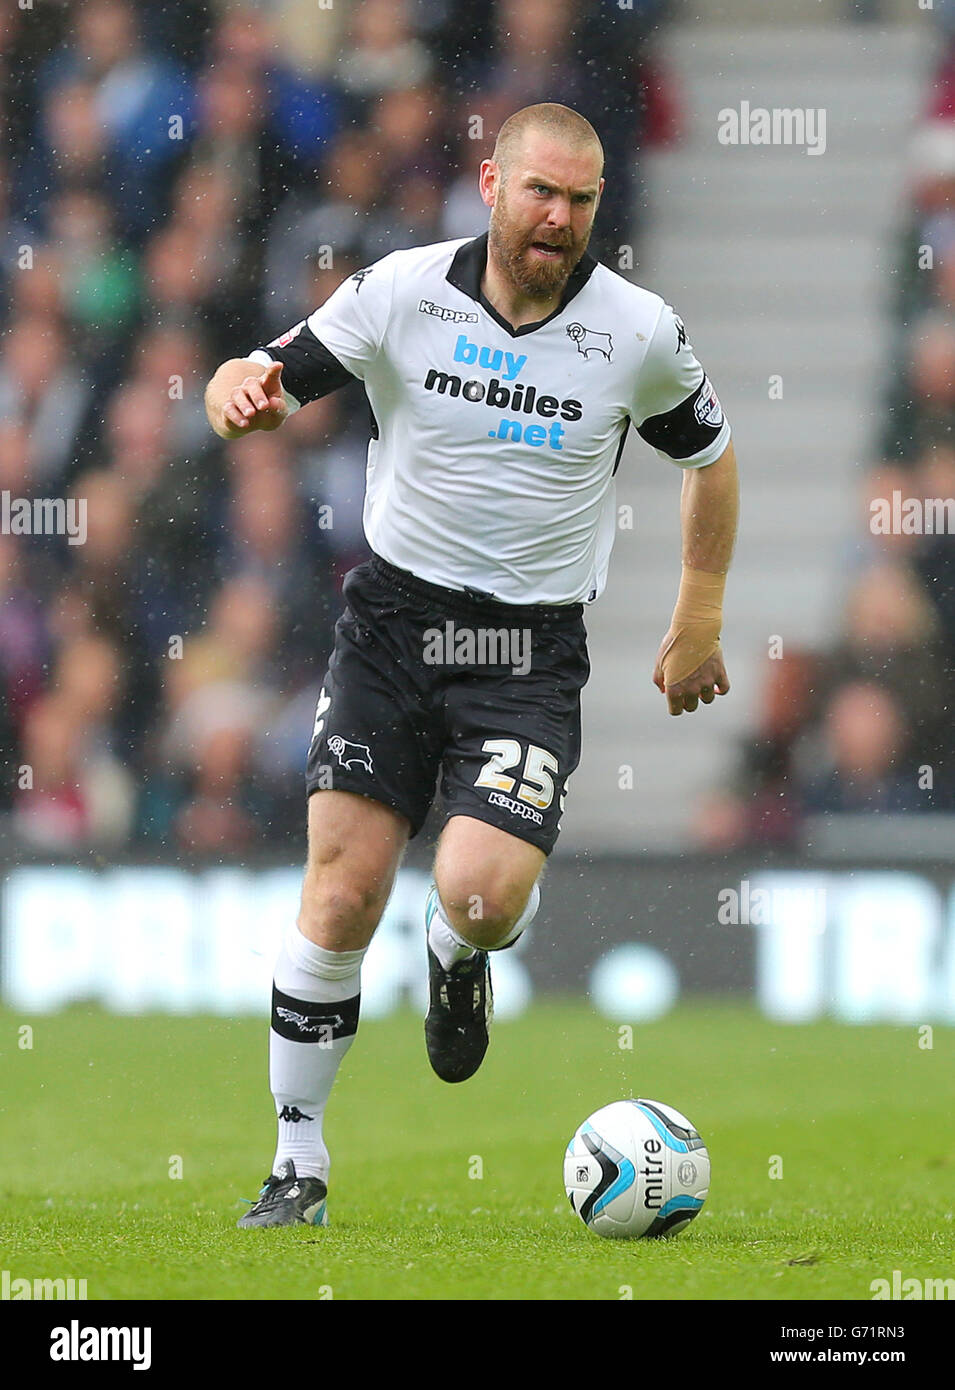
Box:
[564,1101,709,1238]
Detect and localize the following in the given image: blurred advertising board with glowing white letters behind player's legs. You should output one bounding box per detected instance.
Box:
[0,859,955,1024]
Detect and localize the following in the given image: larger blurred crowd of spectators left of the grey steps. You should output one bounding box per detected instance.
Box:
[0,0,672,853]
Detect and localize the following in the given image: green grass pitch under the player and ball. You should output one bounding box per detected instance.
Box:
[0,1001,955,1300]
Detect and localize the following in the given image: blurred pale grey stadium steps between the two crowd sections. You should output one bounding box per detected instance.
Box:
[567,19,931,853]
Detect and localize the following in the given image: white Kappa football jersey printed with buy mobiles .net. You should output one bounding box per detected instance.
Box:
[246,234,730,605]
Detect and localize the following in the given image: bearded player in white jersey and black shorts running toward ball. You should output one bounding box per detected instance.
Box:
[206,103,737,1227]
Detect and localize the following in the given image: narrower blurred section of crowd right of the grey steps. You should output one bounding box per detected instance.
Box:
[698,21,955,849]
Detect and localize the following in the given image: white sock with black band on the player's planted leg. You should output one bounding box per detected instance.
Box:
[268,926,364,1182]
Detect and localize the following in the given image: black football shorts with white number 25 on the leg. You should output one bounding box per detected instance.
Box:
[306,556,591,853]
